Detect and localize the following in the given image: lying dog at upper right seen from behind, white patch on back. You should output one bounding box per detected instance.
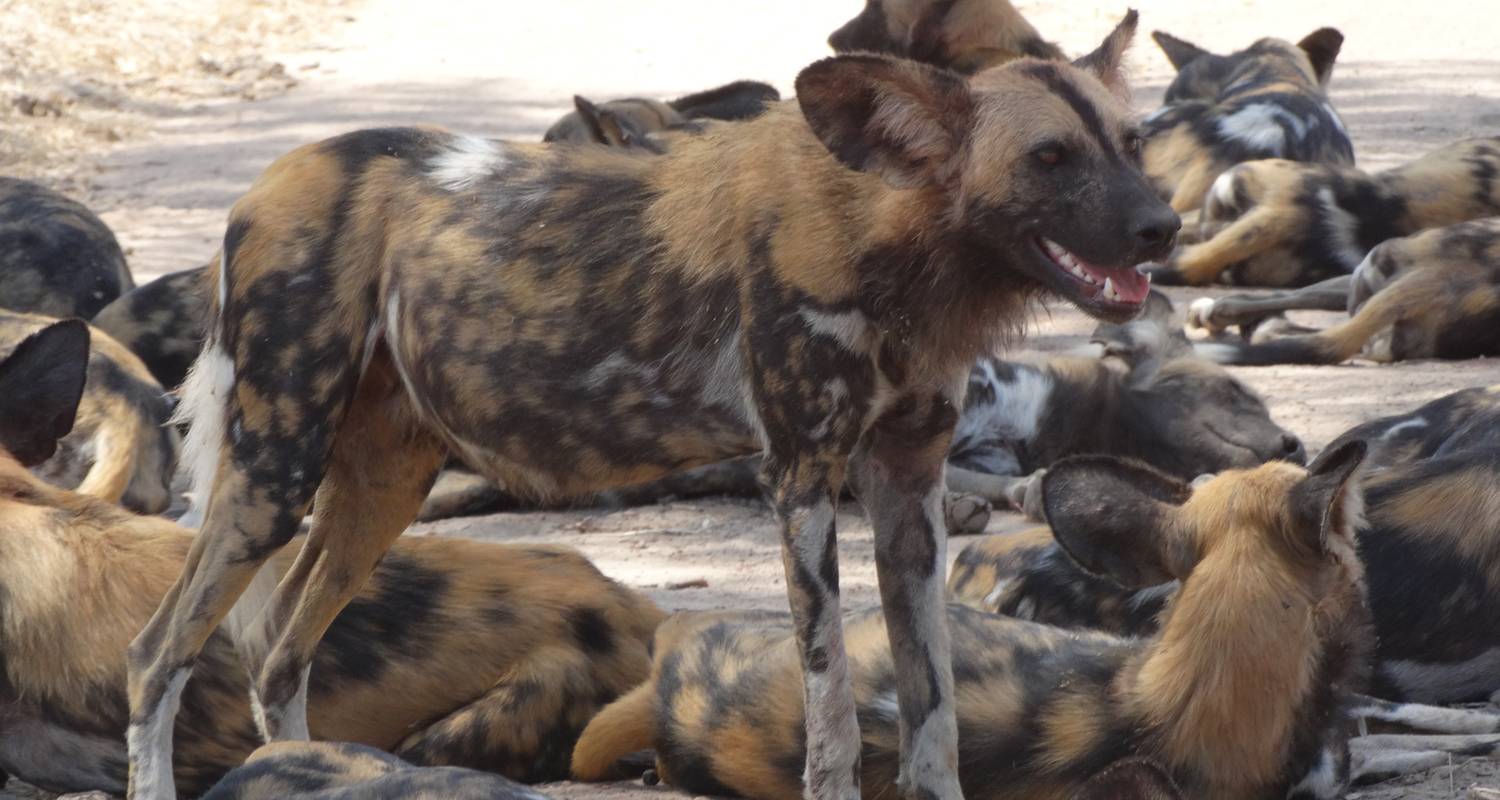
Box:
[1143,29,1355,213]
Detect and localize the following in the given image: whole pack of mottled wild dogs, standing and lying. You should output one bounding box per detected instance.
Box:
[0,0,1500,800]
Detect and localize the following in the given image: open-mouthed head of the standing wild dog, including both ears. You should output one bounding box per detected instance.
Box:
[797,12,1181,320]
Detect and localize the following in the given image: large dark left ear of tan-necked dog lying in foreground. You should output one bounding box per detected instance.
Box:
[1041,456,1197,588]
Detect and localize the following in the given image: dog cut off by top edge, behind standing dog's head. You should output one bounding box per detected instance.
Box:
[828,0,1065,74]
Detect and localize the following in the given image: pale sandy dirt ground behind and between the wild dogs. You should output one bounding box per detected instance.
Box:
[0,0,1500,798]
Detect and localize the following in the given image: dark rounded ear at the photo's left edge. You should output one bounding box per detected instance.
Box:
[0,320,89,467]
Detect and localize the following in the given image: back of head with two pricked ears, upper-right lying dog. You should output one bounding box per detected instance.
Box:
[1151,29,1344,104]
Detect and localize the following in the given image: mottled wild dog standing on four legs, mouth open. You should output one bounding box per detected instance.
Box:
[129,14,1179,800]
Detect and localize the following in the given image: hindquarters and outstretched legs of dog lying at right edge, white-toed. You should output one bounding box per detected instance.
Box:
[1188,218,1500,365]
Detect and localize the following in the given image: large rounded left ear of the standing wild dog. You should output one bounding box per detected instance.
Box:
[797,54,974,189]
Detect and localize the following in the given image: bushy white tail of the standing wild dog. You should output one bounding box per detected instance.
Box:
[171,339,234,528]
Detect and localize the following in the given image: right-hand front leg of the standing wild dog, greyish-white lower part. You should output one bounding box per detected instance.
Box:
[851,392,963,800]
